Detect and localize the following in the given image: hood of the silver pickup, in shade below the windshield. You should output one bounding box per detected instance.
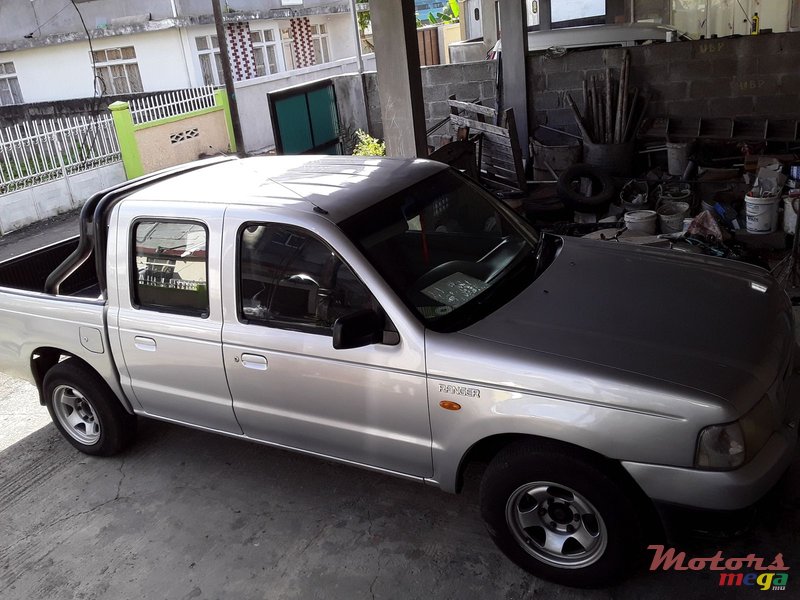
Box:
[461,236,793,412]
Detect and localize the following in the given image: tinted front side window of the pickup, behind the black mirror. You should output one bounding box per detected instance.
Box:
[239,224,377,335]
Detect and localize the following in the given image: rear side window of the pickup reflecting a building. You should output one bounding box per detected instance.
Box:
[131,221,208,317]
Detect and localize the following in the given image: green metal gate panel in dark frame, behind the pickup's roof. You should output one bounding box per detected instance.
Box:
[267,80,342,154]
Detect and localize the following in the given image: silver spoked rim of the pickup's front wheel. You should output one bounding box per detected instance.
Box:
[506,481,608,569]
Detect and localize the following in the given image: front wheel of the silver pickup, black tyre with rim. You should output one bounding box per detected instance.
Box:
[480,441,646,588]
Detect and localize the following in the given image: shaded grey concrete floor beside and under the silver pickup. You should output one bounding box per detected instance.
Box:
[0,420,800,600]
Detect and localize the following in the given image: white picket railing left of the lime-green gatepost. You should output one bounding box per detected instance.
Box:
[0,115,121,194]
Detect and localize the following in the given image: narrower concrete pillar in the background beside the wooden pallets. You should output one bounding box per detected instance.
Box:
[500,0,528,159]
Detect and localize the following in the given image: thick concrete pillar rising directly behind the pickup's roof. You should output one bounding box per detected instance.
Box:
[369,0,428,158]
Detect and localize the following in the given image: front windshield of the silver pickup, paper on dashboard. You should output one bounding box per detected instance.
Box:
[341,171,536,331]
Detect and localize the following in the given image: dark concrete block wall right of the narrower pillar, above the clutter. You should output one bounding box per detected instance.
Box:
[527,33,800,139]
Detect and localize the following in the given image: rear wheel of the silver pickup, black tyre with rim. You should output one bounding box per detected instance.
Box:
[42,359,136,456]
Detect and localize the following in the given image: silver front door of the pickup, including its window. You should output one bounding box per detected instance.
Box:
[223,217,432,477]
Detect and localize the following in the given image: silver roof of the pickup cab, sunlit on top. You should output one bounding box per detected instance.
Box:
[128,156,447,223]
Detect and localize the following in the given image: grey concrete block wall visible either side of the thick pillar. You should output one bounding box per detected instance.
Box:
[366,60,497,147]
